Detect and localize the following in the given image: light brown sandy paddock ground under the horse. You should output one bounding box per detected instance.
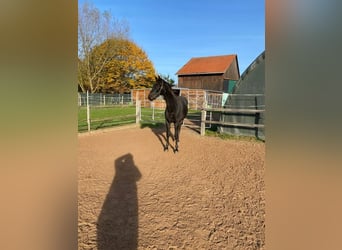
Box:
[78,127,265,250]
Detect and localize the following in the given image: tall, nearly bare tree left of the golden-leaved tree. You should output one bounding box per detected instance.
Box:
[78,2,129,93]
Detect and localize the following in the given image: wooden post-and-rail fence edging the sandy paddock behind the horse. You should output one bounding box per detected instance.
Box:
[79,89,265,135]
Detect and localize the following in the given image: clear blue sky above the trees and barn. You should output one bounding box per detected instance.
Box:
[79,0,265,82]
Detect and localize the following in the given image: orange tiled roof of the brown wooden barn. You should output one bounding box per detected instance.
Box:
[176,54,237,75]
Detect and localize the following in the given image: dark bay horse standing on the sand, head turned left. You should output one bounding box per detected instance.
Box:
[148,75,188,152]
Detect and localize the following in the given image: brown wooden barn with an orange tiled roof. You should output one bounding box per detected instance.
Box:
[176,54,240,92]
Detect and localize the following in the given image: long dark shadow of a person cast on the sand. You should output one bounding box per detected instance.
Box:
[97,153,141,250]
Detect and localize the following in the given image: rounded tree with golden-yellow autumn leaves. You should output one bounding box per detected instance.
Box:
[91,38,155,93]
